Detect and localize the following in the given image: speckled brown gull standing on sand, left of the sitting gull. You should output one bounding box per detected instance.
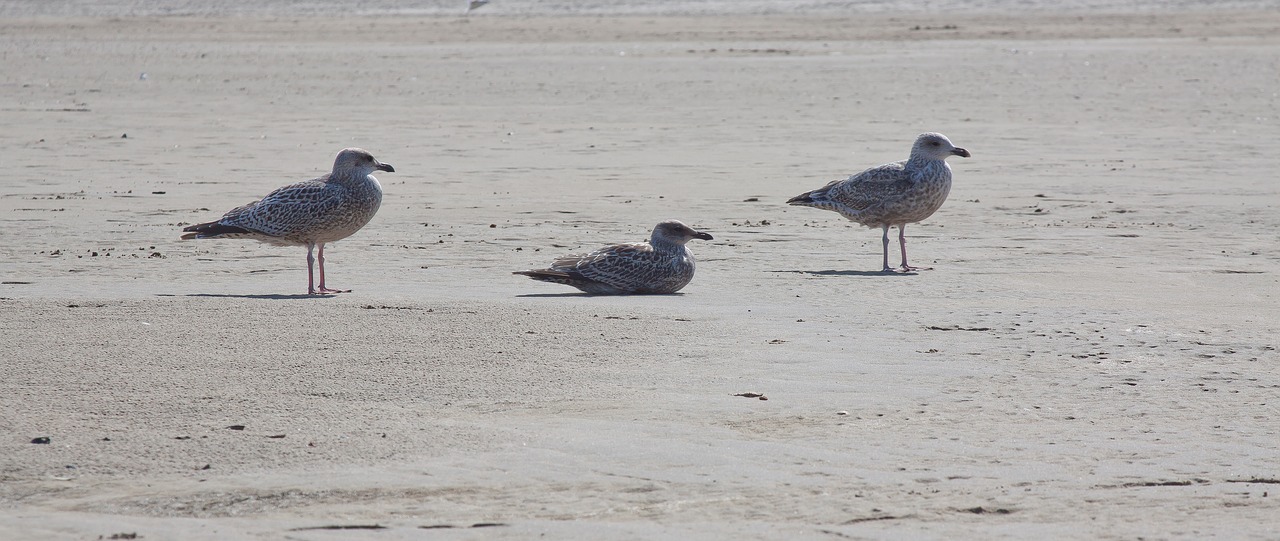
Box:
[182,148,396,295]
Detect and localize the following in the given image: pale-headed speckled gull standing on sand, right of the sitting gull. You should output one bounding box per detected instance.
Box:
[787,133,969,272]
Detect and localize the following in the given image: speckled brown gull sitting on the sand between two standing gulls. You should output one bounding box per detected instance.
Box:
[513,220,712,295]
